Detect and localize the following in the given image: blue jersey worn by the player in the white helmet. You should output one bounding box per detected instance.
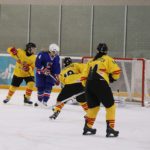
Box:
[35,52,60,87]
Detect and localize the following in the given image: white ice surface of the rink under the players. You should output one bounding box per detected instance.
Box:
[0,89,150,150]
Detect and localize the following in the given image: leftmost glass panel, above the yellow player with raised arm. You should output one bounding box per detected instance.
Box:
[0,5,28,53]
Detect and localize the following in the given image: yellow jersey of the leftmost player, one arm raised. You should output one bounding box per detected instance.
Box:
[7,47,36,77]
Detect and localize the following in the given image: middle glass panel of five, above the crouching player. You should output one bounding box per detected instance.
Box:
[61,6,91,56]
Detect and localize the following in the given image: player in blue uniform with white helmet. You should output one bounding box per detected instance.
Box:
[35,44,60,106]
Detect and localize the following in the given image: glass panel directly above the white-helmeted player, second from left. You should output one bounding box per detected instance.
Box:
[30,5,59,51]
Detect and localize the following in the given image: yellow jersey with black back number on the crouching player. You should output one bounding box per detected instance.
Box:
[59,63,86,85]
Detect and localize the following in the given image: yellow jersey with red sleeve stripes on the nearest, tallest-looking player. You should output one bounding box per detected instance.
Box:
[81,55,121,85]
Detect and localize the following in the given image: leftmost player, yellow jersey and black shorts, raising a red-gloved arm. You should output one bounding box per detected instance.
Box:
[3,43,36,105]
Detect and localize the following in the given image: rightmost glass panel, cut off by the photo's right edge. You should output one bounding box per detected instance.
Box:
[126,6,150,59]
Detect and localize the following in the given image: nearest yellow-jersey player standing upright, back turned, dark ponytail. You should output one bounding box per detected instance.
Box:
[81,43,120,137]
